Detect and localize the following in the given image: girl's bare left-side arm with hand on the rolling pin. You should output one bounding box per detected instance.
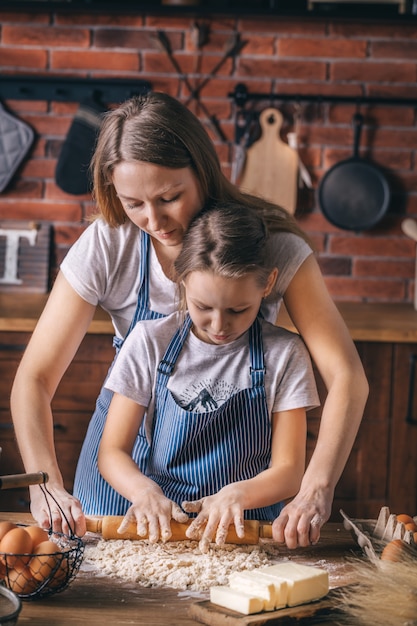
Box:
[98,393,188,543]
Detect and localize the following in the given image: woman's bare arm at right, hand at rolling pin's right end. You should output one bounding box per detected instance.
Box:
[273,255,369,548]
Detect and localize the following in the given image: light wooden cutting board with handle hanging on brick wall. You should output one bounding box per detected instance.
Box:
[240,108,299,214]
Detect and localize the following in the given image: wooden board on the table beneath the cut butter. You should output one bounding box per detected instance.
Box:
[188,587,341,626]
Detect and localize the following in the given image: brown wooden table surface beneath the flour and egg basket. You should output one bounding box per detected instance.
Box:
[0,513,360,626]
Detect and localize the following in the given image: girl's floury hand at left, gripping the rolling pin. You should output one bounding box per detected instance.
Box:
[117,486,189,543]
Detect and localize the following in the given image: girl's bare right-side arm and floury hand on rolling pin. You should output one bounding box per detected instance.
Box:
[183,409,307,552]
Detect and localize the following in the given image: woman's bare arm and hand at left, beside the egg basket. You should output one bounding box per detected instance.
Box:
[11,273,95,536]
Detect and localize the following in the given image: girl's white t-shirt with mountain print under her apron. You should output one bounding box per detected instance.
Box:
[105,313,319,435]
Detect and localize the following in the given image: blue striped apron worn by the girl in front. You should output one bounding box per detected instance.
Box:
[146,316,283,520]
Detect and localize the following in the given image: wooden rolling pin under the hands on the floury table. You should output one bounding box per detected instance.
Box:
[86,515,272,544]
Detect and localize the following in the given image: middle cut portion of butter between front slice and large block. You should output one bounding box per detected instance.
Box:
[229,569,287,611]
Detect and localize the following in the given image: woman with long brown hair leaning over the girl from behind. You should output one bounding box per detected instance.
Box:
[11,93,368,548]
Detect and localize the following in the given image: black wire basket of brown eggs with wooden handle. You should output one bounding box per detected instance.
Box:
[0,478,84,600]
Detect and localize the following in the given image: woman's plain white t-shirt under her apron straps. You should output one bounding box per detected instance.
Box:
[61,218,312,338]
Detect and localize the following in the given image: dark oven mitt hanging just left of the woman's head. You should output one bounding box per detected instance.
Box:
[55,98,106,195]
